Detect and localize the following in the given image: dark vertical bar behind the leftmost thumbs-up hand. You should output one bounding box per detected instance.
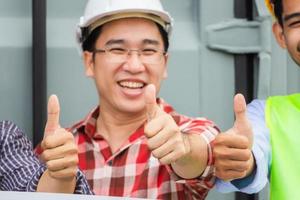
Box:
[32,0,47,146]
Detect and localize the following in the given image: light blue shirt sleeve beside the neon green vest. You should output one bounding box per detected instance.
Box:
[216,100,271,194]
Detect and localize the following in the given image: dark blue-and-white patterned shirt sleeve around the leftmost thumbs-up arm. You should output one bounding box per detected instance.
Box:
[0,121,92,194]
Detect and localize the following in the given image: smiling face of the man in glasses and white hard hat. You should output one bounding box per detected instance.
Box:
[84,18,167,114]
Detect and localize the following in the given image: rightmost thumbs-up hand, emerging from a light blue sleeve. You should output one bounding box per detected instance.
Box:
[213,94,255,181]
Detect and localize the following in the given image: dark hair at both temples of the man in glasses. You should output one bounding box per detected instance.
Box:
[82,23,169,52]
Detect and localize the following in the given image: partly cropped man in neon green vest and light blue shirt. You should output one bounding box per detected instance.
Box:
[213,0,300,200]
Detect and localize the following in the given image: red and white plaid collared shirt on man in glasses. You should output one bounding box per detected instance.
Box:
[59,99,218,199]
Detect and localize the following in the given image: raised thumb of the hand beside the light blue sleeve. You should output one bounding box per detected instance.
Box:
[233,94,252,142]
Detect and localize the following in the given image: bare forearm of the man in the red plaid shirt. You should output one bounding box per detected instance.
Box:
[171,134,208,179]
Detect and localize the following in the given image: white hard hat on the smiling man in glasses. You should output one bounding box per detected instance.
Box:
[76,0,173,52]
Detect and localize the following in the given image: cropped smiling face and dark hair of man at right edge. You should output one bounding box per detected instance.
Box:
[273,0,300,66]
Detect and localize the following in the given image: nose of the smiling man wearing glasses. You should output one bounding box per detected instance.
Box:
[123,51,145,73]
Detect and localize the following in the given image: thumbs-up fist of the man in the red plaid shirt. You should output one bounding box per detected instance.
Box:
[144,84,190,164]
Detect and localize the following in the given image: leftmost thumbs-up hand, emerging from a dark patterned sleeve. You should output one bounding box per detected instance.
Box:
[41,95,78,180]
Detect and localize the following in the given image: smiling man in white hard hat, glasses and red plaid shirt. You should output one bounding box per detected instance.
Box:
[37,0,218,199]
